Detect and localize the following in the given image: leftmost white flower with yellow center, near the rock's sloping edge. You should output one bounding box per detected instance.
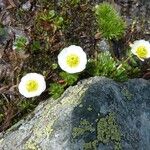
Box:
[18,73,46,98]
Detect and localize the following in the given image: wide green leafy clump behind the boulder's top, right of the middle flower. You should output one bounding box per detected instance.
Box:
[87,52,139,81]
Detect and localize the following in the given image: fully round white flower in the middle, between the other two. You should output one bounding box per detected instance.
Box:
[58,45,87,73]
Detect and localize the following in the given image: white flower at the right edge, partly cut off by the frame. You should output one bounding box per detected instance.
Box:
[130,40,150,61]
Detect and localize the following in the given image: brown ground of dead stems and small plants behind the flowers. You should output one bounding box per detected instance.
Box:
[0,0,150,131]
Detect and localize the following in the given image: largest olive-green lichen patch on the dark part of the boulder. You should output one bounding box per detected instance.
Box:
[97,113,121,150]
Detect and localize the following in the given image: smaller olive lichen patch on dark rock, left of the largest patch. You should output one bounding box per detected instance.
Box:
[72,119,95,138]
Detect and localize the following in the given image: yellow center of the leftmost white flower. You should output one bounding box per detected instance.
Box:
[26,80,38,92]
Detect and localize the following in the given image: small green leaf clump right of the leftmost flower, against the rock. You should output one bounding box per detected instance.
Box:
[49,83,64,99]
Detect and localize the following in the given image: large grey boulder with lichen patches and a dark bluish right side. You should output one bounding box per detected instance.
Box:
[0,77,150,150]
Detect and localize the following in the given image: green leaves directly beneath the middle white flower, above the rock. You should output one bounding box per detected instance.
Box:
[59,72,78,85]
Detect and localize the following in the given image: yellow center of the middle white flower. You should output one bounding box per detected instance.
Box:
[67,54,80,68]
